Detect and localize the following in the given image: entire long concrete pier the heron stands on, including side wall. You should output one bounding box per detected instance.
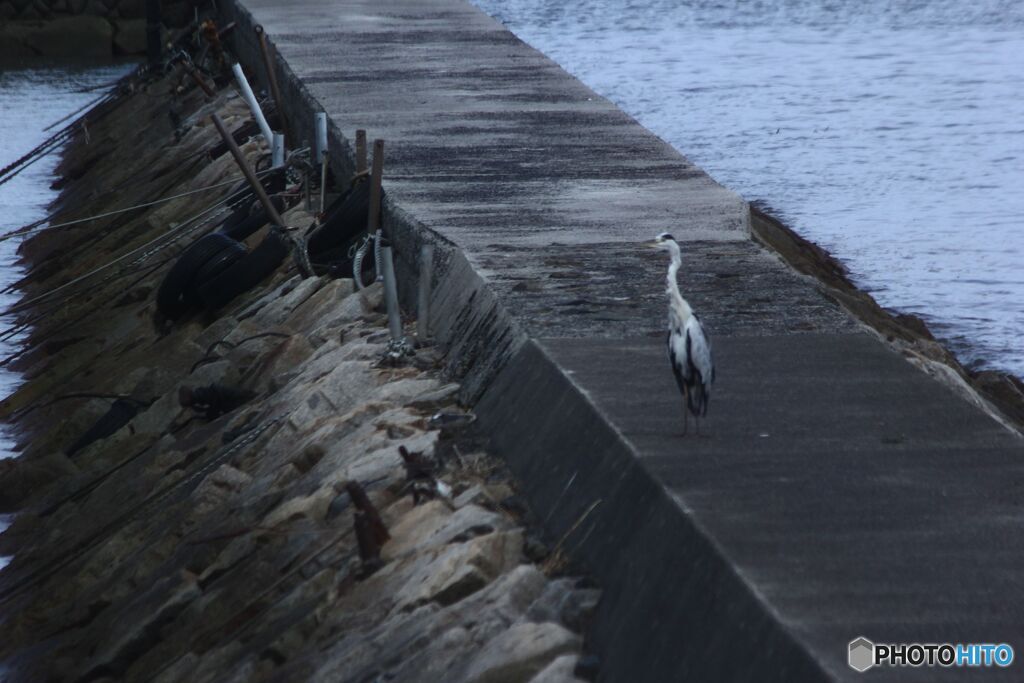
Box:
[220,0,1024,681]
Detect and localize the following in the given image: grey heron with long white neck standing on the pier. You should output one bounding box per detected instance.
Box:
[650,232,715,434]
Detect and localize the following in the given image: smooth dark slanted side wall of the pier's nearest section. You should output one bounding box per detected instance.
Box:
[477,340,827,681]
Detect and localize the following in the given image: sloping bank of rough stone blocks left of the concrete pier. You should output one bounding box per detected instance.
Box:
[0,50,599,682]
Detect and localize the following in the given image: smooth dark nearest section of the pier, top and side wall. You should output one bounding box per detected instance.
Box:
[479,334,1024,681]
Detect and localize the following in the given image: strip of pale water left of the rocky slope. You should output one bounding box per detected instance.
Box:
[0,63,131,567]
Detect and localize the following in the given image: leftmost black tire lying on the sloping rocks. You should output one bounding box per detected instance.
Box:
[157,232,246,321]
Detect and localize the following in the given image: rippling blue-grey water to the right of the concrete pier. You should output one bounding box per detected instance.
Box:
[475,0,1024,376]
